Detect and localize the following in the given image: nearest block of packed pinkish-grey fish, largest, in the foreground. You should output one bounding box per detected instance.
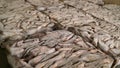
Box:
[8,27,113,68]
